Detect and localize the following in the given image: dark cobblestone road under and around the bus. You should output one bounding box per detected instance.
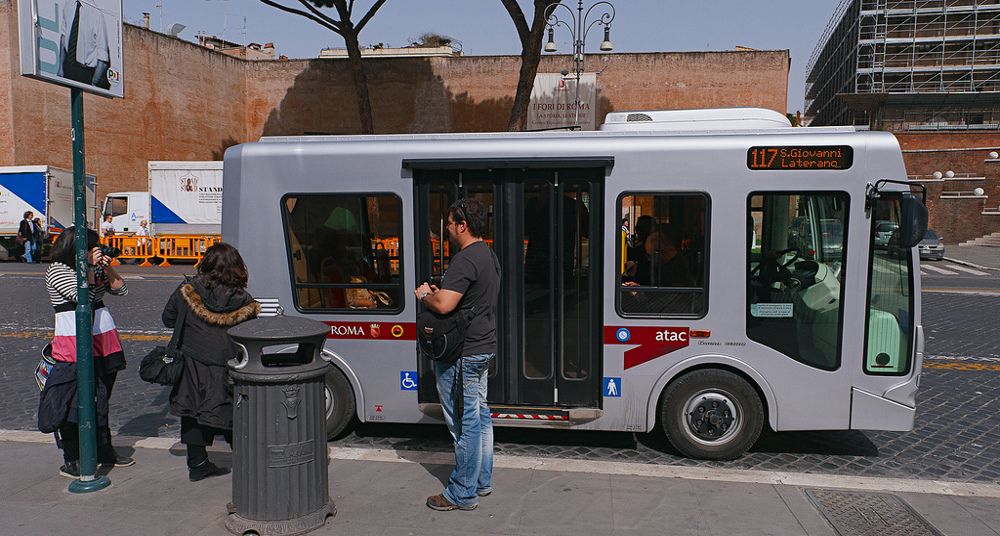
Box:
[0,261,1000,482]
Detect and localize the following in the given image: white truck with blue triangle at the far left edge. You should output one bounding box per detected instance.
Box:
[0,166,97,260]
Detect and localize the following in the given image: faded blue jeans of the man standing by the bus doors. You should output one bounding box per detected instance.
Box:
[434,354,496,506]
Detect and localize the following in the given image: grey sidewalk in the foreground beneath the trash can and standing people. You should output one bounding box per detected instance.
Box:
[0,431,1000,536]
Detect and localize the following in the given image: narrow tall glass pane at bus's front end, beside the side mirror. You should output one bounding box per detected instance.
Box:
[865,196,913,375]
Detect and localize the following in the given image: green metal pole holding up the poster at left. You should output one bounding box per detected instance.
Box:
[69,88,111,493]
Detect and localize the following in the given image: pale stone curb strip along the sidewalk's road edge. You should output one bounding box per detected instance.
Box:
[0,430,1000,498]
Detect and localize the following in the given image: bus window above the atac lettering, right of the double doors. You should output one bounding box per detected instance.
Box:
[616,193,708,317]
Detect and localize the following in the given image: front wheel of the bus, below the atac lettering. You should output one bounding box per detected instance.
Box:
[660,369,764,460]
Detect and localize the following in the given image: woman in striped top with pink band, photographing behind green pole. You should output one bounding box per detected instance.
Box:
[38,227,135,478]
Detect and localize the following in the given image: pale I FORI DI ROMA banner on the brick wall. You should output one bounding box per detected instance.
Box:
[527,73,597,130]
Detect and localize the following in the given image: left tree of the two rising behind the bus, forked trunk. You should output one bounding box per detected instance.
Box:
[260,0,386,134]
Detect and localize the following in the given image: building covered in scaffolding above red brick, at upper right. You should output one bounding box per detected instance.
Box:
[805,0,1000,243]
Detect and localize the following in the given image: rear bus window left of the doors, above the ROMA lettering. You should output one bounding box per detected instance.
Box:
[281,194,403,313]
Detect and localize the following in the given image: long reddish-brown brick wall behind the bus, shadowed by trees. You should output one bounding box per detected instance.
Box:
[0,0,789,199]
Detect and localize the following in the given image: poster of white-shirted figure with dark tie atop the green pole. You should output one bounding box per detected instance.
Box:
[17,0,125,98]
